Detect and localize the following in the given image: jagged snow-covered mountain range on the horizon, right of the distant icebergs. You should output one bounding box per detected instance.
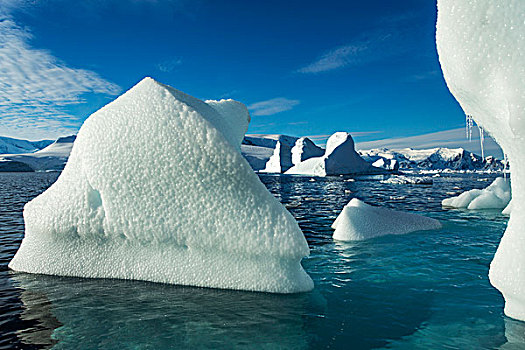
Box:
[358,147,504,170]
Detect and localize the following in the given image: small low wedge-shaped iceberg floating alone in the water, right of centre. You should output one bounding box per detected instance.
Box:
[332,198,441,241]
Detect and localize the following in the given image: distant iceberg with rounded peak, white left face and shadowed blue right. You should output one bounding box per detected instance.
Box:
[286,132,387,176]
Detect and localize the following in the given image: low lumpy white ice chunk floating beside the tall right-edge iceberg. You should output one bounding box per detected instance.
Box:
[441,177,510,210]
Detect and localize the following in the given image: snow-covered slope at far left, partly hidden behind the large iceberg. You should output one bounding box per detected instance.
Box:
[0,135,76,171]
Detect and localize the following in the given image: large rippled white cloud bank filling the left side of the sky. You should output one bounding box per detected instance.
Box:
[0,2,120,138]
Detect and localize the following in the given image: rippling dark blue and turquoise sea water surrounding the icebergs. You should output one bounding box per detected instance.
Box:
[0,173,525,349]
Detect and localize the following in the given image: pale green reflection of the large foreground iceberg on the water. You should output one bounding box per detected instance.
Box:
[12,273,319,349]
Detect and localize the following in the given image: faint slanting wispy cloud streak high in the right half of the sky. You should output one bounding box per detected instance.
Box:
[296,14,413,74]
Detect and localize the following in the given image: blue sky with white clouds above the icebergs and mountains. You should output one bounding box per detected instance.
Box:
[0,0,464,142]
